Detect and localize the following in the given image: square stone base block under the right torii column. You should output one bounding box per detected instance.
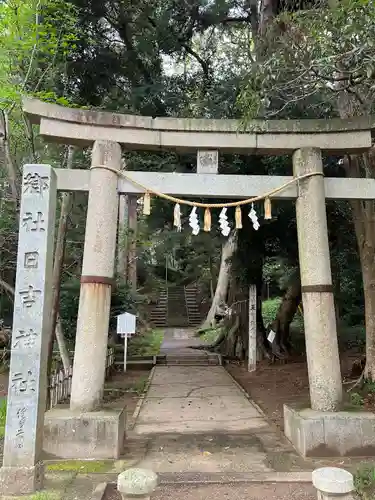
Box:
[284,405,375,457]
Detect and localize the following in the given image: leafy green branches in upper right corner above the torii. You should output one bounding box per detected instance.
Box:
[238,0,375,118]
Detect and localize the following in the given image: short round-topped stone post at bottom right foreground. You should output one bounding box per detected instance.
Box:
[312,467,354,500]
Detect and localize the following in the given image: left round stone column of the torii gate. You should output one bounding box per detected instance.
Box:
[70,141,121,412]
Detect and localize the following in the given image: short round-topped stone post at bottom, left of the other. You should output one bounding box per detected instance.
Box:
[117,469,158,500]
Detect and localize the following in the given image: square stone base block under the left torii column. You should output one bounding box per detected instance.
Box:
[43,408,126,459]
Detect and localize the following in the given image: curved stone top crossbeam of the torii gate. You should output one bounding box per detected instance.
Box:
[23,98,375,155]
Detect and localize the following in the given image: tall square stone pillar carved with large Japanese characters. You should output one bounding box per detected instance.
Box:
[0,165,56,495]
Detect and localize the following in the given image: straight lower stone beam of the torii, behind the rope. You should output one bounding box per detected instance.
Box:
[55,169,375,200]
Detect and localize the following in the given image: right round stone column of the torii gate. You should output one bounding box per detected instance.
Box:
[293,148,342,411]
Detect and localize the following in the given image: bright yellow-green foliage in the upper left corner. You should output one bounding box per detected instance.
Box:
[0,0,76,109]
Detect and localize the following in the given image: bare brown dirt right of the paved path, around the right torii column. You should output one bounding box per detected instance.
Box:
[226,351,364,430]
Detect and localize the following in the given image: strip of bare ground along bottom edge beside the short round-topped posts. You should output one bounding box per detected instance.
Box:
[104,483,316,500]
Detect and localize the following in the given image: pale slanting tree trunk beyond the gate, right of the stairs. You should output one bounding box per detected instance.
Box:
[203,232,237,327]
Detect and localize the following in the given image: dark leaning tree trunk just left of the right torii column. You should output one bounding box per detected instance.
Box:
[267,276,301,357]
